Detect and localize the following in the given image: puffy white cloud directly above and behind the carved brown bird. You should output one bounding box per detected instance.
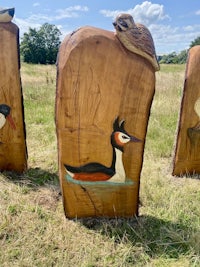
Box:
[100,1,170,26]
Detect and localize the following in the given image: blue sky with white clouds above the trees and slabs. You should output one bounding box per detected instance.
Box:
[0,0,200,55]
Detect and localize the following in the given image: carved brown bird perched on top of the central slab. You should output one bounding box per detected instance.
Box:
[113,13,160,71]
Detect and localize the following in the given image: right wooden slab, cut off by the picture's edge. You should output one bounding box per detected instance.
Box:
[173,46,200,176]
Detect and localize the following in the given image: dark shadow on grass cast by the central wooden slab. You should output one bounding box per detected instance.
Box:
[79,215,199,263]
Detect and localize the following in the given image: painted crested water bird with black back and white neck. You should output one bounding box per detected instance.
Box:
[64,117,141,182]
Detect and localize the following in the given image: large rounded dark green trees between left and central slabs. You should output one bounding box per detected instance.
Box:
[21,23,61,64]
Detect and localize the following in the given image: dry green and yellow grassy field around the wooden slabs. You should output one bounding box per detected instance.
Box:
[0,64,200,267]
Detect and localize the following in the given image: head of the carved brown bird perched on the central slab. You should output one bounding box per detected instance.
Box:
[113,13,135,32]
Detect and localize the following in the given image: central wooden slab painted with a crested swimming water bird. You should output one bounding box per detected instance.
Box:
[56,27,155,218]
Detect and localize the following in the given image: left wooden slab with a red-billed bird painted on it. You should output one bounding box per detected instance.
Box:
[0,22,27,172]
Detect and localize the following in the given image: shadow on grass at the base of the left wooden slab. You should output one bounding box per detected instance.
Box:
[2,168,59,190]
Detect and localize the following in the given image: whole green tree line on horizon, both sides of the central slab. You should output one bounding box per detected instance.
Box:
[20,23,200,64]
